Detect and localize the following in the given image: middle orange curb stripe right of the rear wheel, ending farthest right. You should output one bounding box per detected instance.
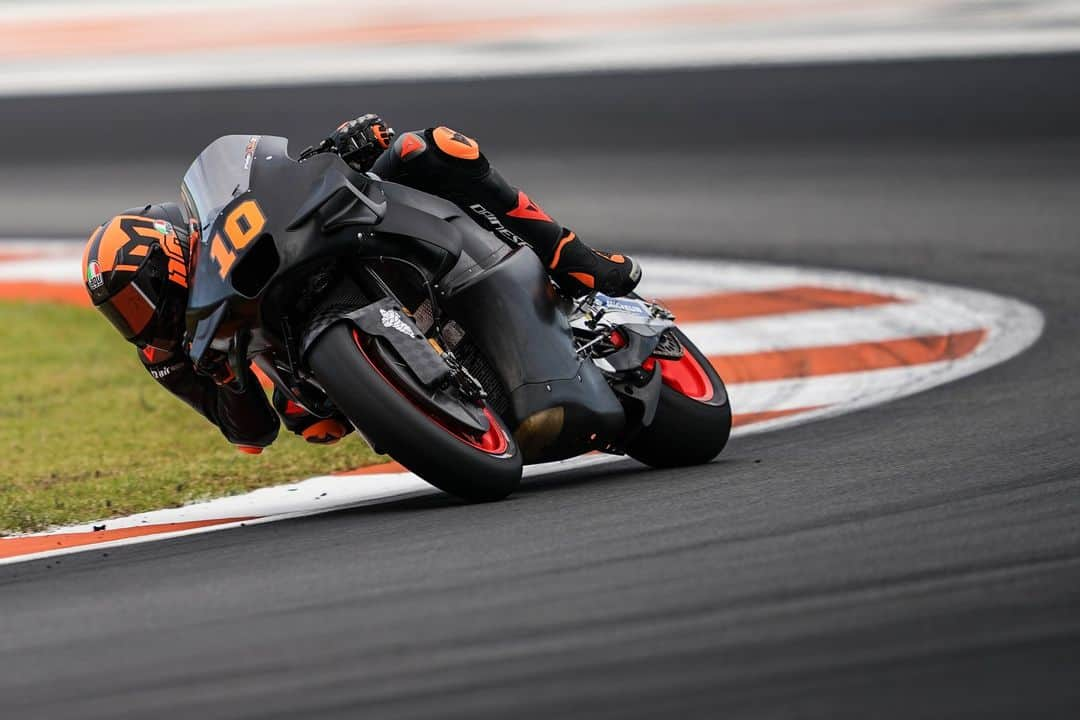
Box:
[708,329,986,384]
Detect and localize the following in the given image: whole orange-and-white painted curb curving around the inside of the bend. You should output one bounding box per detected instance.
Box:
[0,245,1043,565]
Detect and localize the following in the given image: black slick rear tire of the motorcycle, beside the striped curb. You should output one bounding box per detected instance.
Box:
[626,330,731,467]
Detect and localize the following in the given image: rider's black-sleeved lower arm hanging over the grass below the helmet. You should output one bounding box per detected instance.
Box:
[138,352,280,448]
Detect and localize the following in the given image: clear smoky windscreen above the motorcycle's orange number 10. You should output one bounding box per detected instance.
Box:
[180,135,261,231]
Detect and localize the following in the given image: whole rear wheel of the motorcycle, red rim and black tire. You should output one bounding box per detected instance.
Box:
[626,329,731,467]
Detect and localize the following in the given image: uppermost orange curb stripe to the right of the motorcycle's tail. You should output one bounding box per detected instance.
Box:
[664,285,901,323]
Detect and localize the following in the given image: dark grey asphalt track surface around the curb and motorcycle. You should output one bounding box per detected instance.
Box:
[0,56,1080,720]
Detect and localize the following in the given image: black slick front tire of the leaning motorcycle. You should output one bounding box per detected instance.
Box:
[308,323,522,502]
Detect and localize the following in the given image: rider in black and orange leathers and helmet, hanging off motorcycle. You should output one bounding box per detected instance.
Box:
[82,114,640,453]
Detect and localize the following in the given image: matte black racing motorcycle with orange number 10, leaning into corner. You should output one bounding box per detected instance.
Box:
[181,135,731,501]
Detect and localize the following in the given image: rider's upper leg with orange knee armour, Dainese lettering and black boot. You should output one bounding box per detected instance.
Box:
[372,127,642,295]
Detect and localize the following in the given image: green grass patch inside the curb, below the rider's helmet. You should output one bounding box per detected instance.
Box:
[0,302,381,534]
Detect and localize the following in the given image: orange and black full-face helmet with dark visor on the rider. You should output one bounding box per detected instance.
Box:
[82,203,188,349]
